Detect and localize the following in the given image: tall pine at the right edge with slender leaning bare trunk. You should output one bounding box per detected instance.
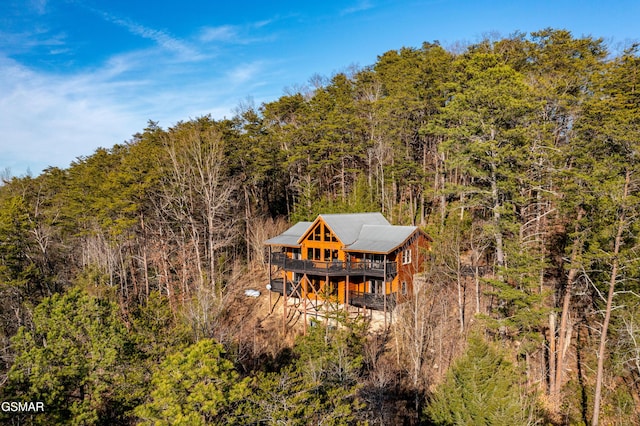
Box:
[577,46,640,425]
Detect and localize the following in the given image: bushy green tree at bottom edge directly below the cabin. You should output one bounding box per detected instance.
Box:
[244,323,363,426]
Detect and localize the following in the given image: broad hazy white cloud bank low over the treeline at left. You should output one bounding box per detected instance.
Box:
[0,50,272,175]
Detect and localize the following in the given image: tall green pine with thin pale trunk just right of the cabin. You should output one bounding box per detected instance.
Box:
[428,50,544,342]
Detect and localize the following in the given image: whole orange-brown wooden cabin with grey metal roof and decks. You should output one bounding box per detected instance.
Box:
[265,213,431,312]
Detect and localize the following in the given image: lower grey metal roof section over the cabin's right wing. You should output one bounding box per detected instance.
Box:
[344,225,418,253]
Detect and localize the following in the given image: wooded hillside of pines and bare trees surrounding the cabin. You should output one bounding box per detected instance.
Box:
[0,29,640,425]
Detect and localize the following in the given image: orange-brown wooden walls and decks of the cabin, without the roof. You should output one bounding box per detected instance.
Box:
[270,217,430,310]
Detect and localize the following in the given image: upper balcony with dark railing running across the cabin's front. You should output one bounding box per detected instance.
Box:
[271,253,398,281]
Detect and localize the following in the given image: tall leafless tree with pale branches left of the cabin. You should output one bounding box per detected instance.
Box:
[161,120,239,310]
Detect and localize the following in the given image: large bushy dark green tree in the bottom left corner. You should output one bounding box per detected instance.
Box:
[4,290,136,425]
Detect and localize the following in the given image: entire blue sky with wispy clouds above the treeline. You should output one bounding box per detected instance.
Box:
[0,0,640,176]
